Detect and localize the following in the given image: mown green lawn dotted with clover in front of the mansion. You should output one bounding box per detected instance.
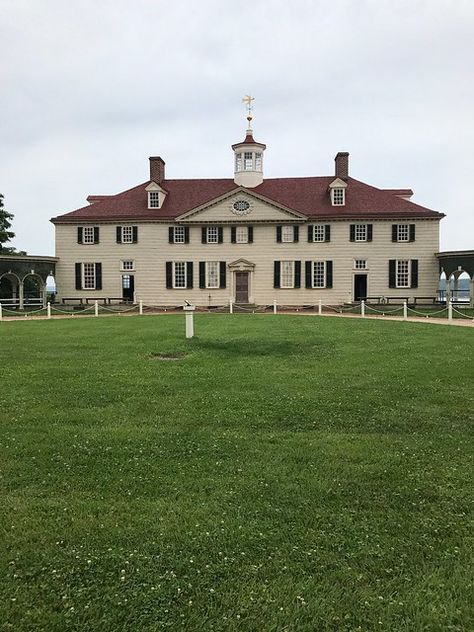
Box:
[0,314,474,632]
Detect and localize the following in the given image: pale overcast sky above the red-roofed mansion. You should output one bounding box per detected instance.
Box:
[0,0,474,255]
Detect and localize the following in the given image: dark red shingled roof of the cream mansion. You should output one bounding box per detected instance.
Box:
[51,176,444,224]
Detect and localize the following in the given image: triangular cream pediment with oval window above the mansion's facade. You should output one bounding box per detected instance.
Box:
[176,187,306,224]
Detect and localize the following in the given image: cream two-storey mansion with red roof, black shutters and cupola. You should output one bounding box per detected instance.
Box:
[51,123,444,306]
